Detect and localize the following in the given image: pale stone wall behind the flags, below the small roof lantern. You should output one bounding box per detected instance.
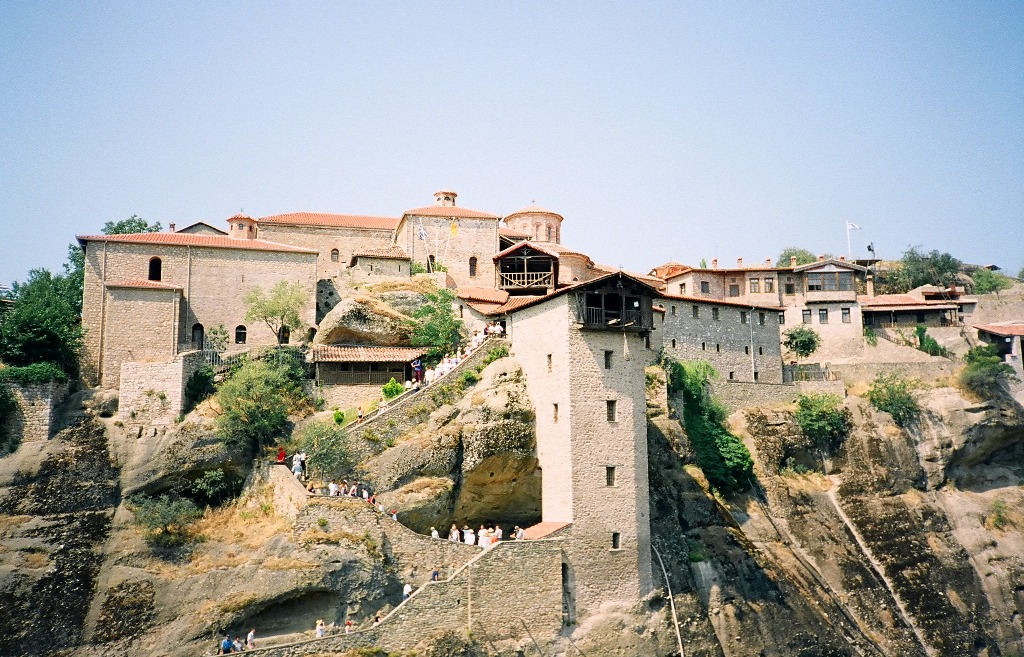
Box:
[395,215,499,288]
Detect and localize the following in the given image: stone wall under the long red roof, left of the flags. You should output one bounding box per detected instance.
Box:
[258,223,392,278]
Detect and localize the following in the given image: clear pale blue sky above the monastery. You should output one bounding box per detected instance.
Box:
[0,0,1024,282]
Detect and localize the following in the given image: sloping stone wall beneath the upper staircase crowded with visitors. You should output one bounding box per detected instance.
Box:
[348,338,509,461]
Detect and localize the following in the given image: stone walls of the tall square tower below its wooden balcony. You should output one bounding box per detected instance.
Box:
[509,295,652,613]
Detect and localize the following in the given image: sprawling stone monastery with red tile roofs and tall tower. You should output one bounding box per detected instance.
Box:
[78,186,864,613]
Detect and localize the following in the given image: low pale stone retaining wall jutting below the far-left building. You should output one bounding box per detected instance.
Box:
[118,351,203,427]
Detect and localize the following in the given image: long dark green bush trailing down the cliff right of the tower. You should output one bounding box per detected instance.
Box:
[663,358,754,494]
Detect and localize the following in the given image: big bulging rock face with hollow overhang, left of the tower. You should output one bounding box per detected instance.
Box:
[361,357,541,533]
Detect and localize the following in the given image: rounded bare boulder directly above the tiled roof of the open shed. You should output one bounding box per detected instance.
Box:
[313,297,410,347]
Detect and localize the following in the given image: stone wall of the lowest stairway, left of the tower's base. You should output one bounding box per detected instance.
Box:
[249,540,563,657]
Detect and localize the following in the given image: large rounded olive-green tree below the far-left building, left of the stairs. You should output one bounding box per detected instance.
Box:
[216,360,306,451]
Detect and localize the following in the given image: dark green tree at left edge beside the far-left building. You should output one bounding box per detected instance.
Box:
[0,269,82,377]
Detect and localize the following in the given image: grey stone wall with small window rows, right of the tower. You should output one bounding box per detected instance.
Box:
[653,298,782,383]
